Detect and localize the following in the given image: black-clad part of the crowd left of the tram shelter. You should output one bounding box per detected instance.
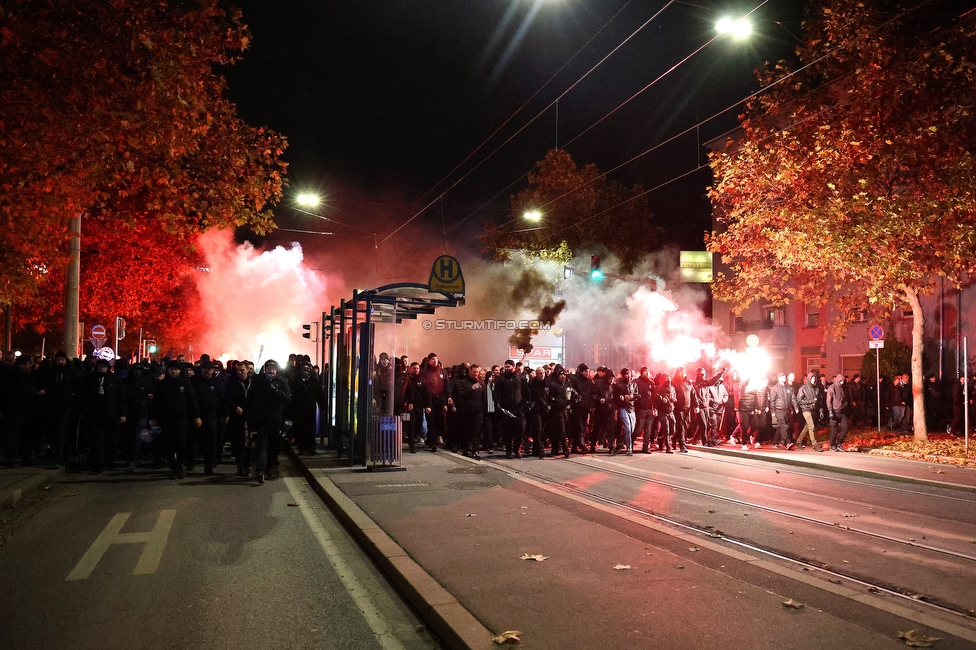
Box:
[0,351,325,483]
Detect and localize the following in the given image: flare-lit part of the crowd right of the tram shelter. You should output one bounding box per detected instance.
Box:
[374,353,972,458]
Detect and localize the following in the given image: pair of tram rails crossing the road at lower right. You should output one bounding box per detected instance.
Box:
[483,459,976,623]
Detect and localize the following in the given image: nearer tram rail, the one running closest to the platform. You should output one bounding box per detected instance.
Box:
[482,459,973,621]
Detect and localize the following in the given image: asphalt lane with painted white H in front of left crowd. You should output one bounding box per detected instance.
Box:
[0,460,440,650]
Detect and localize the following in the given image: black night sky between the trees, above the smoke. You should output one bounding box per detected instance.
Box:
[227,0,801,249]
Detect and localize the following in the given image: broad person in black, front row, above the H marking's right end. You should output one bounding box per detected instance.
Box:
[149,361,203,479]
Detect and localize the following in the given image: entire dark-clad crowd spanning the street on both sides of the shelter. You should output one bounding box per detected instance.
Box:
[0,344,973,476]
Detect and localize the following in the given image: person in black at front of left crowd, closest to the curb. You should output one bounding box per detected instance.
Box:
[247,359,291,484]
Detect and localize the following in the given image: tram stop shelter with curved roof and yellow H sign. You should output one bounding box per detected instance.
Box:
[322,255,464,469]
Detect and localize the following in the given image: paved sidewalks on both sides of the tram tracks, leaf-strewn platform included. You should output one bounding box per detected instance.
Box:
[294,447,976,650]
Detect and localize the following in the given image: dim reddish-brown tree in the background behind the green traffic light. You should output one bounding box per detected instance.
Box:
[483,149,660,270]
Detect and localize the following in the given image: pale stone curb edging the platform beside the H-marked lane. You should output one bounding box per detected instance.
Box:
[283,444,494,650]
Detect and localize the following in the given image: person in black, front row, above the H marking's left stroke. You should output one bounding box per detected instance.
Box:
[81,359,127,474]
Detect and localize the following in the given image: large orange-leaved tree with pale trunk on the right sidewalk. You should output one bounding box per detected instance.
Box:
[707,0,976,440]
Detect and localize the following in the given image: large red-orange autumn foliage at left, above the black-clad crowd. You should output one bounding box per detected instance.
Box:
[0,0,285,344]
